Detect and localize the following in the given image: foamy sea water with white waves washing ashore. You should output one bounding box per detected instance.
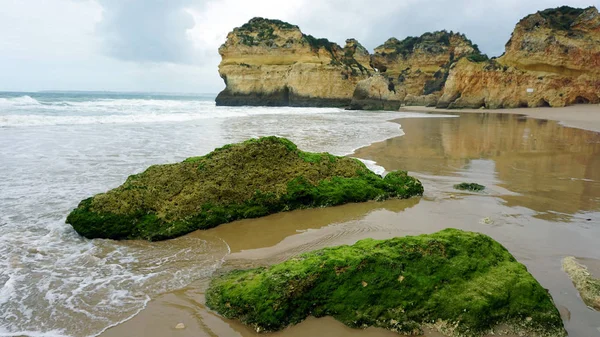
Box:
[0,92,452,336]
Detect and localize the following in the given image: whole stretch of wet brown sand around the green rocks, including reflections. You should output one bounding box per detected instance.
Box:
[102,113,600,337]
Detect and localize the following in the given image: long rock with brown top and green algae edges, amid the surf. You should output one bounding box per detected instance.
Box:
[67,137,423,240]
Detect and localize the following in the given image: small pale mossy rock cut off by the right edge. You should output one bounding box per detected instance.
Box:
[562,256,600,311]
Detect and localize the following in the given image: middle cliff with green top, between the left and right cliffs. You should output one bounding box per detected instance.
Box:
[351,31,481,110]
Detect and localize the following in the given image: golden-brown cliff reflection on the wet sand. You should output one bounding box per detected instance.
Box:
[356,114,600,221]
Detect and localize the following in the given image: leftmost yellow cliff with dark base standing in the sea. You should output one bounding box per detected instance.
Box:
[216,18,372,107]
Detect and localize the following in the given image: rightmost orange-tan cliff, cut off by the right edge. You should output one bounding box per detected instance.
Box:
[437,7,600,109]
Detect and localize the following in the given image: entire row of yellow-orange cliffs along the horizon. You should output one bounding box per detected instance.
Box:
[216,6,600,110]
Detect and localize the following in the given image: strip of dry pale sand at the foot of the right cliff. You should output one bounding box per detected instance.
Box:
[399,104,600,132]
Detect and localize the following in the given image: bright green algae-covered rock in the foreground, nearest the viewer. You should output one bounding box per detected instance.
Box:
[206,229,566,336]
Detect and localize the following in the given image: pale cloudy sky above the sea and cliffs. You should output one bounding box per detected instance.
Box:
[0,0,599,93]
